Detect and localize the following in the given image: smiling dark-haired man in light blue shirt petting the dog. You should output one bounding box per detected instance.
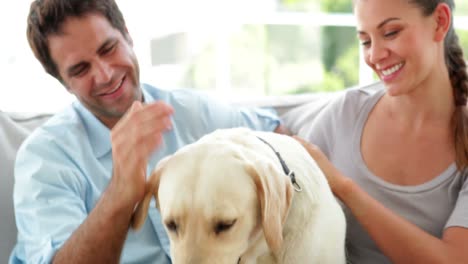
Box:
[10,0,288,263]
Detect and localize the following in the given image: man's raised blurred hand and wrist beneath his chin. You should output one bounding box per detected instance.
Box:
[109,101,173,211]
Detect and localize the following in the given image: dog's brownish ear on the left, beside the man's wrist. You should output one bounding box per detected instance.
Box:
[132,156,170,230]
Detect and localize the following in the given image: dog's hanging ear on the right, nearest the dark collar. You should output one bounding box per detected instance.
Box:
[247,160,294,252]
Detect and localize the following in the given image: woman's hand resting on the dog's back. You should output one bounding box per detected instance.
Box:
[293,136,347,195]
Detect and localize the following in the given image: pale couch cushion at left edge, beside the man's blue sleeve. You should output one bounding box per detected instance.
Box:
[0,112,50,263]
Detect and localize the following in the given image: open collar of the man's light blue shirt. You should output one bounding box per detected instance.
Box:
[74,85,155,158]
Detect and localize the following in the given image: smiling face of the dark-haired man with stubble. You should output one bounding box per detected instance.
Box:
[48,14,142,128]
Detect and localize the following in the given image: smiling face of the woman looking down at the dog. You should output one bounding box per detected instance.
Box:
[354,0,443,95]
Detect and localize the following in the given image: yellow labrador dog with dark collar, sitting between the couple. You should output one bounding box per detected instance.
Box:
[133,128,346,264]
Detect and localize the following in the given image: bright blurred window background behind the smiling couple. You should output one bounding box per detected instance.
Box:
[0,0,468,112]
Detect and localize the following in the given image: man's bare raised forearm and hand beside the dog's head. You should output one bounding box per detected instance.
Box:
[53,102,172,263]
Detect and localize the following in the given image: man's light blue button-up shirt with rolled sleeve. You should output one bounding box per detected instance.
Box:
[10,84,279,264]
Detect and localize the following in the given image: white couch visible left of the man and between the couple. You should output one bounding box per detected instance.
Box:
[0,82,356,263]
